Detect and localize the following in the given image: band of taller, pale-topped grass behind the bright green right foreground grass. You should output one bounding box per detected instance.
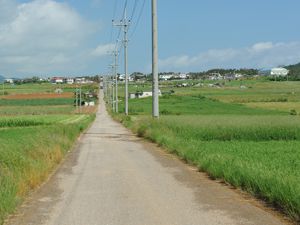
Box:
[151,115,300,141]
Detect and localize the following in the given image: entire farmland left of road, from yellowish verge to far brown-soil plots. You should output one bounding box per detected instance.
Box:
[0,84,98,224]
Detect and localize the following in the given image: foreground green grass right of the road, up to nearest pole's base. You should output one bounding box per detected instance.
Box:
[116,115,300,222]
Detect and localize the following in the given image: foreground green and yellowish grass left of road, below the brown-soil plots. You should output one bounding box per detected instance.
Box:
[0,115,95,224]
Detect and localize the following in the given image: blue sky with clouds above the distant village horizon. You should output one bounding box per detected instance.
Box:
[0,0,300,77]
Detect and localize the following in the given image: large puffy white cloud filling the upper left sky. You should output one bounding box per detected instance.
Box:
[0,0,96,74]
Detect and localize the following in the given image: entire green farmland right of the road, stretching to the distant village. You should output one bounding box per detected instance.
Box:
[113,80,300,223]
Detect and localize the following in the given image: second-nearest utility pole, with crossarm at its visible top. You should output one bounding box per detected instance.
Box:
[113,9,130,115]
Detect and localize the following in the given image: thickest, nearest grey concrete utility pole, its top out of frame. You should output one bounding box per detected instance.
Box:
[152,0,159,118]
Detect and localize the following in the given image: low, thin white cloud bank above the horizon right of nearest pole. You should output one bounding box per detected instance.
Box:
[159,42,300,70]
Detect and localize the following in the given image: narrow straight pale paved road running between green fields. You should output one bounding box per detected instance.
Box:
[7,90,285,225]
